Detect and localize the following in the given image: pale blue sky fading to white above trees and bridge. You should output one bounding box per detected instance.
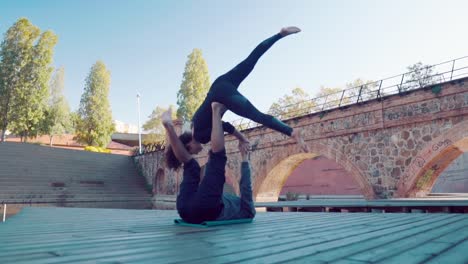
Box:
[0,0,468,129]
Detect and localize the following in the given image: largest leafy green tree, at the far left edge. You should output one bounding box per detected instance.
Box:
[0,18,57,141]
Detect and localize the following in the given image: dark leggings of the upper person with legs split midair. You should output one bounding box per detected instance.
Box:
[207,34,292,136]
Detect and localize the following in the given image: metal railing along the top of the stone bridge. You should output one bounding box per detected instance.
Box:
[231,56,468,130]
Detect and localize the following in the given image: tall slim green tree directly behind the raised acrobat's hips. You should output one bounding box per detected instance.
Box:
[177,49,210,121]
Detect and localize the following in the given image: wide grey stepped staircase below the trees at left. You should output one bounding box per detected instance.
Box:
[0,142,151,214]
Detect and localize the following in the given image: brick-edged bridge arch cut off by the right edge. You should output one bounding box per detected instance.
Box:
[397,120,468,197]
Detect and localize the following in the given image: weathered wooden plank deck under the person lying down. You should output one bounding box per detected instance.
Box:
[0,207,468,264]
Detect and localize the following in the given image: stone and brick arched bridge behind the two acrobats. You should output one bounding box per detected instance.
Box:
[136,78,468,201]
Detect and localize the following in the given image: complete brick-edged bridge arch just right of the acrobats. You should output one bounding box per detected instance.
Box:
[254,143,375,202]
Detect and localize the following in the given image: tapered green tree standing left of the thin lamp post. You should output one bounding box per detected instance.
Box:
[75,61,115,148]
